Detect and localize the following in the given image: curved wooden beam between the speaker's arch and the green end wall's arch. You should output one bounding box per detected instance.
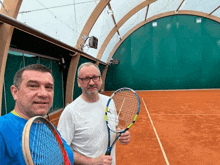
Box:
[97,0,157,59]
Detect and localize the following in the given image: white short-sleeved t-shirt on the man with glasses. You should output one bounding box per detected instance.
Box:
[57,94,116,165]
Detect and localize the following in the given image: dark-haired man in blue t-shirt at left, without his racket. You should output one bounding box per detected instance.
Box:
[0,64,73,165]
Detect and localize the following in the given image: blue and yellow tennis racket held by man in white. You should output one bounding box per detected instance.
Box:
[105,87,140,155]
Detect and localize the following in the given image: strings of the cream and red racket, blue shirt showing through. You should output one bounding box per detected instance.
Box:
[30,119,64,165]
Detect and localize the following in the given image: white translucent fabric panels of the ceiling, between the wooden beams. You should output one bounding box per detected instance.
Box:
[14,0,220,62]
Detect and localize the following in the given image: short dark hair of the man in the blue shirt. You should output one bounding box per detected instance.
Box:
[13,64,53,89]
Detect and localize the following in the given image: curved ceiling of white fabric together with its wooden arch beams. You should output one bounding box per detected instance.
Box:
[11,0,220,62]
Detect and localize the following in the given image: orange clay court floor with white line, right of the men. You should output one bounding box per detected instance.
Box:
[103,90,220,165]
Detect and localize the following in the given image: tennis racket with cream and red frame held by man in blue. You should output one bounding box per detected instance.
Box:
[22,116,71,165]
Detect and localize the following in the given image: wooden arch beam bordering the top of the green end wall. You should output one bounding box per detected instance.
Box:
[109,10,220,62]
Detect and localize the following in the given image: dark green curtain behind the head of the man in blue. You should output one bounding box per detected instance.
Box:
[1,52,64,115]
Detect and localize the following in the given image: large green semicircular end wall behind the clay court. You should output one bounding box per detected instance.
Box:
[105,15,220,90]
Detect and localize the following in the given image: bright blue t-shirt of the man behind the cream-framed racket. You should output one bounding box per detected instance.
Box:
[0,113,73,165]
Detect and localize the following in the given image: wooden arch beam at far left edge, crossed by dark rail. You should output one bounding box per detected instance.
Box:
[0,0,22,116]
